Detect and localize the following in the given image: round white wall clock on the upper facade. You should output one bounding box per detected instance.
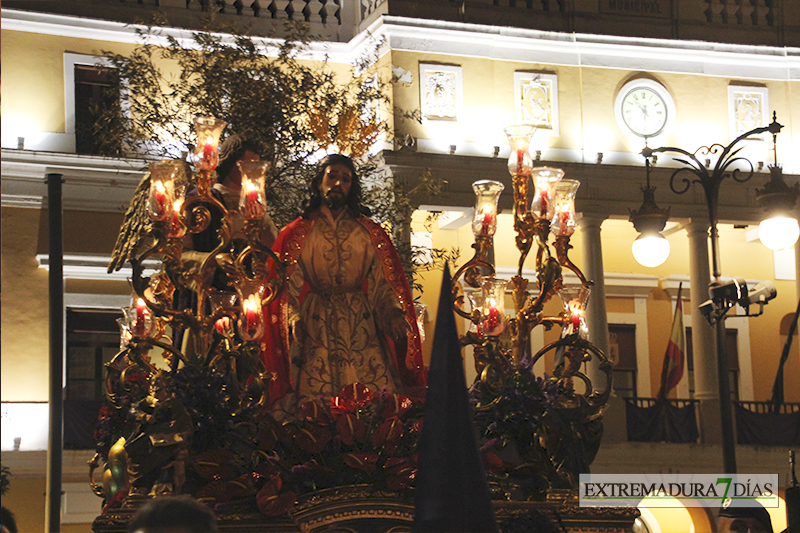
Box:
[614,79,675,137]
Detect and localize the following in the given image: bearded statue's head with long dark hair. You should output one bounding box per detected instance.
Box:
[303,154,370,218]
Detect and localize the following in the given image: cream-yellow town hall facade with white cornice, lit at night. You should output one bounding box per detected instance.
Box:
[2,0,800,531]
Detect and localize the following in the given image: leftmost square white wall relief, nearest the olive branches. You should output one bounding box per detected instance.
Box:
[419,63,463,121]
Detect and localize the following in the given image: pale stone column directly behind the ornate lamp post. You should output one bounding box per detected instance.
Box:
[686,219,722,444]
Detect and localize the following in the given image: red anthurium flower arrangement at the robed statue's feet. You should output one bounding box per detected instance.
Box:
[96,380,423,516]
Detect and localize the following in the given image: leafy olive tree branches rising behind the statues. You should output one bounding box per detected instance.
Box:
[95,16,387,226]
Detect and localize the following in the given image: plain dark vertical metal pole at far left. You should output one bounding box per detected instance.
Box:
[45,174,64,533]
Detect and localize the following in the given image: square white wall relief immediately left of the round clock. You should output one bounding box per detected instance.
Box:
[514,72,559,135]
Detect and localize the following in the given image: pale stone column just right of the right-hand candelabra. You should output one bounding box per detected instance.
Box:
[580,214,610,390]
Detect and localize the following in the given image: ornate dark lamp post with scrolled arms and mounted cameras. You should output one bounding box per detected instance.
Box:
[632,113,798,473]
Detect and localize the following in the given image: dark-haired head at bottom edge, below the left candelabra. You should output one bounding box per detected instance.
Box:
[128,496,218,533]
